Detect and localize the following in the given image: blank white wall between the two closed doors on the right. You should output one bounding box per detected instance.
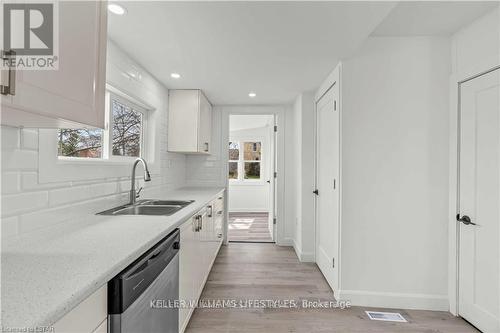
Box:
[340,37,451,310]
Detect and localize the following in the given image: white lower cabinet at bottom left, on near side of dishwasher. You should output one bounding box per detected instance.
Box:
[53,284,108,333]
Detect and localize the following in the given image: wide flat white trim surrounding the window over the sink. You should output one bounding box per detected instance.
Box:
[38,85,160,183]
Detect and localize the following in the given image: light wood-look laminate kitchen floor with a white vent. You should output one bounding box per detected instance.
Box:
[186,243,478,333]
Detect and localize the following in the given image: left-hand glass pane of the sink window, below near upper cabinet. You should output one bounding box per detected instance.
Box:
[58,129,102,158]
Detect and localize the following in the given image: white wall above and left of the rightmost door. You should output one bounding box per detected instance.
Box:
[448,7,500,314]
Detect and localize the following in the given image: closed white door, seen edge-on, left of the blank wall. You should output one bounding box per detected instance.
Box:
[316,85,340,290]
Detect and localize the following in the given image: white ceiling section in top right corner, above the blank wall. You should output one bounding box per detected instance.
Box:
[372,1,499,36]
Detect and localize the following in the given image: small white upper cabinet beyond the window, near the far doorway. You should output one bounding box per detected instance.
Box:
[168,90,212,154]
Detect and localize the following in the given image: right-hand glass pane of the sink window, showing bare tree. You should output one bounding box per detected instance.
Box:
[111,100,142,157]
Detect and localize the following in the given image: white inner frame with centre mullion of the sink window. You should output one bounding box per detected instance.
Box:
[57,88,149,163]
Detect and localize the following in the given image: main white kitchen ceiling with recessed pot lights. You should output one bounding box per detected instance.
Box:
[109,1,394,105]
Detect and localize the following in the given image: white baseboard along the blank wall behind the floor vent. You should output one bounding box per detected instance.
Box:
[334,290,449,311]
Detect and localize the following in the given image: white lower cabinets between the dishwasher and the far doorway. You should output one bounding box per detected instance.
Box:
[179,191,223,332]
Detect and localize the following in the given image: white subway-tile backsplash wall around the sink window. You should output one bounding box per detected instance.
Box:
[0,40,185,240]
